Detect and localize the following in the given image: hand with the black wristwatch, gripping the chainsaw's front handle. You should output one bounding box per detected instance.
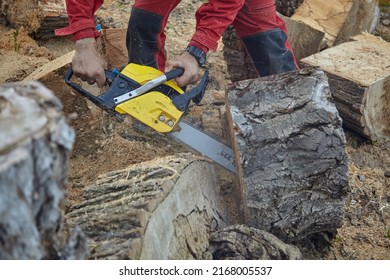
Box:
[165,52,199,87]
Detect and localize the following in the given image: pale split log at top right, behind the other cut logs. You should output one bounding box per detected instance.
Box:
[291,0,379,49]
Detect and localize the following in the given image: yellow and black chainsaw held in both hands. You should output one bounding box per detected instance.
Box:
[65,63,236,173]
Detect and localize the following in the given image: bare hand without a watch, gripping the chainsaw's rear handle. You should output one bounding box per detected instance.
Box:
[72,38,107,87]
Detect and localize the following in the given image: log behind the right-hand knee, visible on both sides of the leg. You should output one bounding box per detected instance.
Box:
[222,16,325,82]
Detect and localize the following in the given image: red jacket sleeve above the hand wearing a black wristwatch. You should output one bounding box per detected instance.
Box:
[190,0,245,53]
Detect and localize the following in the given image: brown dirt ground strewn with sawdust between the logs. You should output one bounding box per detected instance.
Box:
[0,0,390,260]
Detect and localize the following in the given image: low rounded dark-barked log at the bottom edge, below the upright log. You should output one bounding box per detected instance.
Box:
[210,225,302,260]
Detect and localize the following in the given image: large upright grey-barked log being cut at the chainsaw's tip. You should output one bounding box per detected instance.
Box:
[227,68,349,242]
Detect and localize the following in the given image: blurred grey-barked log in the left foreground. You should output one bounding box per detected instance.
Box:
[0,82,88,259]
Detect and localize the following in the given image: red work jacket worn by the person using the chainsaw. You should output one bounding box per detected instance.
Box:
[56,0,245,53]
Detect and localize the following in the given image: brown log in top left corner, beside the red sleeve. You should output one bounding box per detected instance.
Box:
[0,0,68,39]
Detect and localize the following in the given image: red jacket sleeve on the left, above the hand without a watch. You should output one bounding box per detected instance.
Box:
[55,0,104,41]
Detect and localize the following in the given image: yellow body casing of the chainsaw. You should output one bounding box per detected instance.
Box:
[115,63,184,133]
